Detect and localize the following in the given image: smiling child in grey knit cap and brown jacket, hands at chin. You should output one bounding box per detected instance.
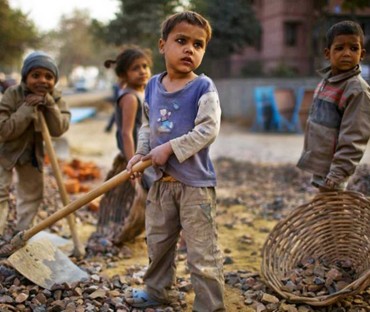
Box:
[0,51,70,235]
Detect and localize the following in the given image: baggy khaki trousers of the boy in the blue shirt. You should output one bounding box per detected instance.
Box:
[144,181,225,312]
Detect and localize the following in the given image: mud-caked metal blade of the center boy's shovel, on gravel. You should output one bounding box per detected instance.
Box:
[8,238,89,290]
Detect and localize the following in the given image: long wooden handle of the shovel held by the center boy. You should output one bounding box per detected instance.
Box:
[22,160,152,241]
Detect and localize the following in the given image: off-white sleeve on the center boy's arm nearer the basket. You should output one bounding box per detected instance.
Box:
[170,92,221,163]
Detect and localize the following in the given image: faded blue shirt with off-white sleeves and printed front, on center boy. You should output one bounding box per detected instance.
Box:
[137,73,221,187]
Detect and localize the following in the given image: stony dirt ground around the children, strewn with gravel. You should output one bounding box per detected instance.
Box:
[0,94,370,312]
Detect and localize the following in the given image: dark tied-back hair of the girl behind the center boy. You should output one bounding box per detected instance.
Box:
[104,45,153,77]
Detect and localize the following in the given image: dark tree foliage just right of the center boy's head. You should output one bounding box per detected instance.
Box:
[191,0,261,58]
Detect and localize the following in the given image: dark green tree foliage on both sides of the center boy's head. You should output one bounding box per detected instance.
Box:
[93,0,260,72]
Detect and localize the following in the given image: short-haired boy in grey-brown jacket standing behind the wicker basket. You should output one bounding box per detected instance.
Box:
[298,21,370,191]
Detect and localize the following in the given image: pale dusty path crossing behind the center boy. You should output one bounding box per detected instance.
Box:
[65,110,370,166]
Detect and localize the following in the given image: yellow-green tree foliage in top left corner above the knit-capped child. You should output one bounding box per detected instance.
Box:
[0,0,39,70]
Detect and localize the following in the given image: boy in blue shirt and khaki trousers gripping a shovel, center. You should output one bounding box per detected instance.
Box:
[126,11,225,312]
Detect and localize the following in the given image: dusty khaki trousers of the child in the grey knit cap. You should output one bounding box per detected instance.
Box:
[0,163,44,231]
